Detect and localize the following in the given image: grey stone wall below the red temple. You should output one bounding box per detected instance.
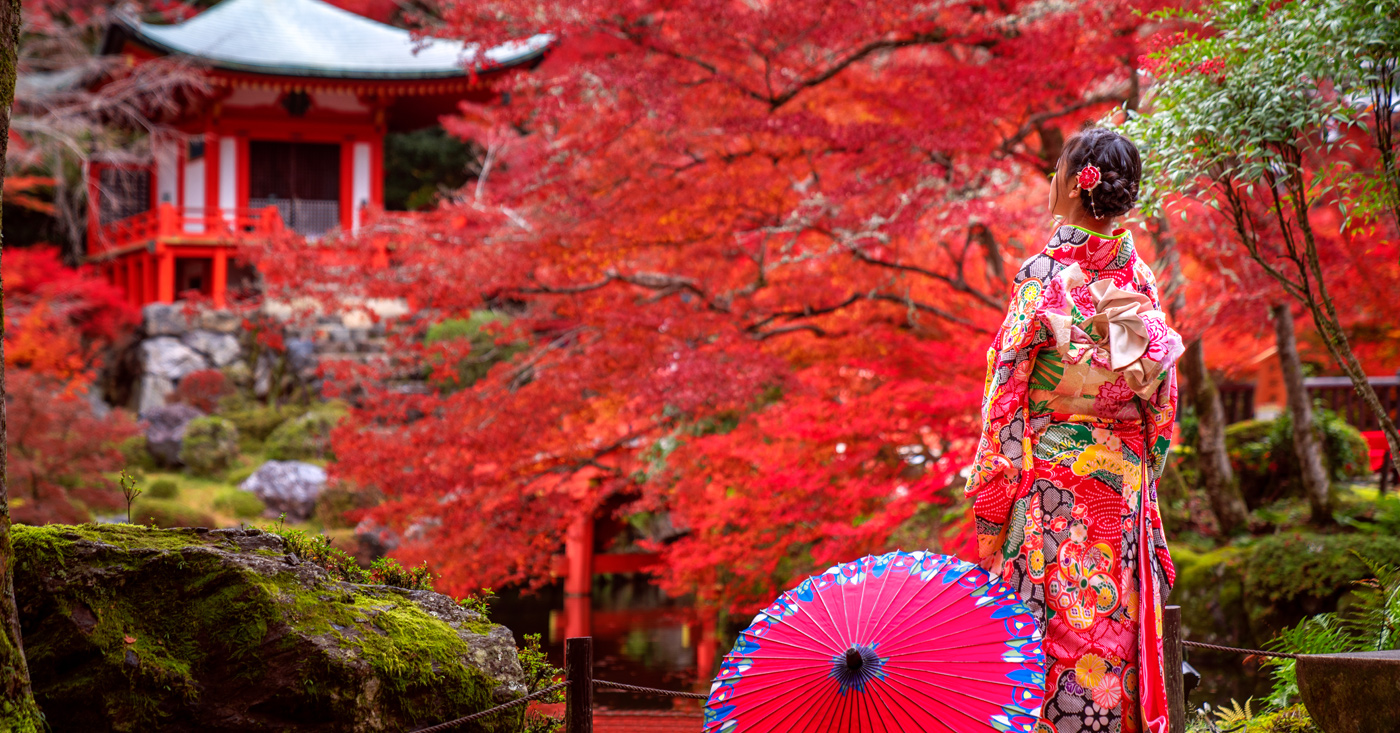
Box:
[119,304,385,414]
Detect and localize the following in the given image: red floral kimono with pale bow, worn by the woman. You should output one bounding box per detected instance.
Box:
[967,225,1182,733]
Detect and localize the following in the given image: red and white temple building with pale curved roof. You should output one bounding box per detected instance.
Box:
[87,0,552,306]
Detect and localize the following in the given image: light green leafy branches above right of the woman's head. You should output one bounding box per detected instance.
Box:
[1124,0,1357,214]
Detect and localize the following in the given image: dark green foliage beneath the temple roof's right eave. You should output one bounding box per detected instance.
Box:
[384,126,480,211]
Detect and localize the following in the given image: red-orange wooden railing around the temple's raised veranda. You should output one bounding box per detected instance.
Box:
[94,204,286,255]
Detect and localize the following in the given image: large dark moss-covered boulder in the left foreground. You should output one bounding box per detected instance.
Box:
[14,525,525,733]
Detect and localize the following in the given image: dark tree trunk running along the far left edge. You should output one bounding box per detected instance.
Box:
[0,0,43,733]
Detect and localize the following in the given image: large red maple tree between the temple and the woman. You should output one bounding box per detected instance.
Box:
[260,0,1181,610]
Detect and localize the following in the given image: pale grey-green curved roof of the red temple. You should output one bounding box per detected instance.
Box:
[108,0,553,80]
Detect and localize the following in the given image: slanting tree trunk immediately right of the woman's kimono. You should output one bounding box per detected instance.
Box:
[1180,339,1249,534]
